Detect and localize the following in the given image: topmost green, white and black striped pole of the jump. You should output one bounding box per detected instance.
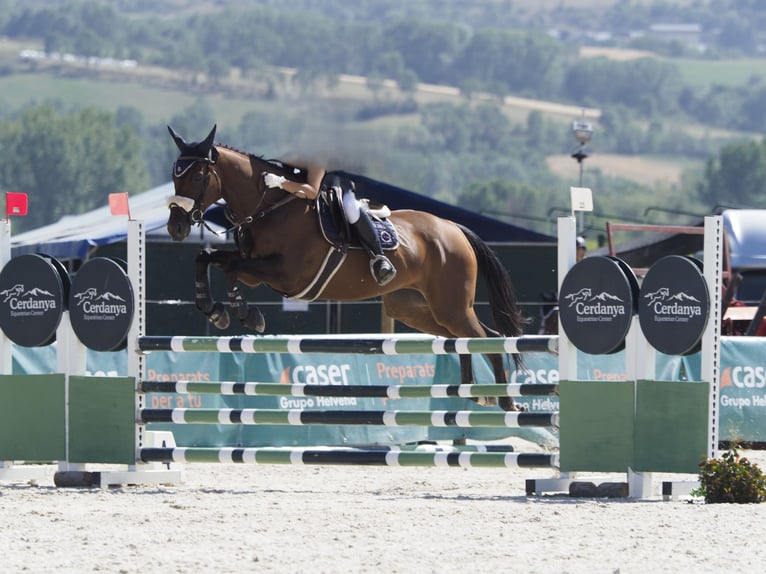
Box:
[137,335,558,355]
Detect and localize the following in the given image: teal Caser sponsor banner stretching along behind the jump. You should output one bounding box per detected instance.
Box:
[13,337,766,446]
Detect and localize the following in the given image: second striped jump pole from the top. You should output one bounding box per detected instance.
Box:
[138,381,559,399]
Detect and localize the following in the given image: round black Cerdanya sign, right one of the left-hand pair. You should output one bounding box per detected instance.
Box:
[69,257,133,351]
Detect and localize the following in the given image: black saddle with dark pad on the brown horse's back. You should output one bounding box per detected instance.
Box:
[316,186,399,251]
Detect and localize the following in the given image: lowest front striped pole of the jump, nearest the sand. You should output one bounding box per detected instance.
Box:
[139,447,559,468]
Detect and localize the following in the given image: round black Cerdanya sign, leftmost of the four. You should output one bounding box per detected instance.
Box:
[0,254,69,347]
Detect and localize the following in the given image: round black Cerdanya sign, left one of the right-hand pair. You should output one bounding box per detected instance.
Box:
[559,256,639,355]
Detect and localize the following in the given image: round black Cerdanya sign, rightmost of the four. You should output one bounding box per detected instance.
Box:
[638,255,710,355]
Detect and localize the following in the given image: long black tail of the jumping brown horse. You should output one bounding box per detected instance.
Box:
[458,224,526,367]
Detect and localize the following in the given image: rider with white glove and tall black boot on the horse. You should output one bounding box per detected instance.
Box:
[263,165,396,286]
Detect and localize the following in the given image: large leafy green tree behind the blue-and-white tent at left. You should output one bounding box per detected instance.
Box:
[0,104,146,229]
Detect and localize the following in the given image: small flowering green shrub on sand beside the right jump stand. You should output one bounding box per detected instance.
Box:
[692,449,766,504]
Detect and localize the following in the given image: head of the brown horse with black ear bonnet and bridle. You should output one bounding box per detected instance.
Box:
[167,126,221,241]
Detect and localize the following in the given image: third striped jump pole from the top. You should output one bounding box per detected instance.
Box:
[138,409,559,428]
